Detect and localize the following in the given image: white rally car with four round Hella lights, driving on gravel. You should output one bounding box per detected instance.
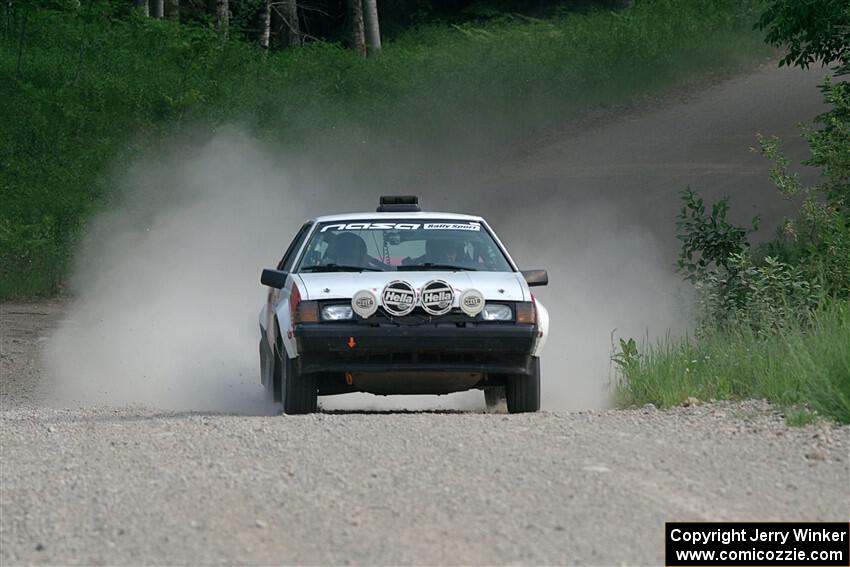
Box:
[260,197,549,414]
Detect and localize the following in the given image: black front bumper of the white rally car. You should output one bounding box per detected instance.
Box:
[295,323,537,374]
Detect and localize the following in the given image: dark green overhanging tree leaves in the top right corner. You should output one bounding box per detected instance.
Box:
[756,0,850,73]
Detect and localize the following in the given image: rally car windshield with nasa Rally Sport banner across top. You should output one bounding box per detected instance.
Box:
[297,219,513,272]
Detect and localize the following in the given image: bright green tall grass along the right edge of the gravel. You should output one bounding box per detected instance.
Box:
[617,302,850,423]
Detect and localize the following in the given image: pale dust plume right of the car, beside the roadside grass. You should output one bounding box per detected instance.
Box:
[504,201,691,410]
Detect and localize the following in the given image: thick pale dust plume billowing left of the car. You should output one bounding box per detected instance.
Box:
[45,130,309,413]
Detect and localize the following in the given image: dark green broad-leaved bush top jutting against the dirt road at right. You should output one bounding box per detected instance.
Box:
[676,187,759,282]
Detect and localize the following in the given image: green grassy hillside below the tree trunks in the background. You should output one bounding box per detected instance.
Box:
[0,0,767,298]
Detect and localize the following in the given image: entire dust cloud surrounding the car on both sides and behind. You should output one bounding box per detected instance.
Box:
[45,127,688,413]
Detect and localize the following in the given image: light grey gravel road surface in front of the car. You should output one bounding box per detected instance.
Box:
[0,302,850,565]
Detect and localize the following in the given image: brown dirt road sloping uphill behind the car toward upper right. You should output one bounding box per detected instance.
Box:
[438,61,827,239]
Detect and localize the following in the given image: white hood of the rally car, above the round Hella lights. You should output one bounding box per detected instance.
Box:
[295,271,531,301]
